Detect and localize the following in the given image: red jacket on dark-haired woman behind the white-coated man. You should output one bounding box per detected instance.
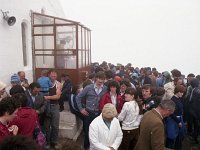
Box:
[99,92,123,113]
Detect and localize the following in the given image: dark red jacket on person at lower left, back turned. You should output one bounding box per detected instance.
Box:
[10,107,38,138]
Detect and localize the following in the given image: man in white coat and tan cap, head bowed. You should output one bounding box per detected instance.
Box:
[89,103,123,150]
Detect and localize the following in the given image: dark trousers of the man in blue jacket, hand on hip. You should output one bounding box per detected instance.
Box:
[83,112,100,149]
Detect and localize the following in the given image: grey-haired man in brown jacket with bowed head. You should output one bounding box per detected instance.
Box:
[134,99,175,150]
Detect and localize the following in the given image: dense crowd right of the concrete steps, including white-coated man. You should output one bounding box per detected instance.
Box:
[73,62,200,150]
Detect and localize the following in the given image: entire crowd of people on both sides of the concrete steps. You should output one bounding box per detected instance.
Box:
[0,62,200,150]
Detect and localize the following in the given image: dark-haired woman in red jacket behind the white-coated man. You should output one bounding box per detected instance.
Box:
[100,81,123,113]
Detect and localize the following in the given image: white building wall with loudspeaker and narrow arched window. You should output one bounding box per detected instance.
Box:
[0,0,65,84]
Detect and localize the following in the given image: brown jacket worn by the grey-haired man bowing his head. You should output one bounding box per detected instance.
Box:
[134,109,165,150]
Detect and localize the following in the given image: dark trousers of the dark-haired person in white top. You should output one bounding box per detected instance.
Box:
[119,128,139,150]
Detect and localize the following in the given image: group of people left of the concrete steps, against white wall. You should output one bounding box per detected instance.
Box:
[0,70,67,150]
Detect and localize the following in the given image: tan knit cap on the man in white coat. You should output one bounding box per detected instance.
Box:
[102,103,117,118]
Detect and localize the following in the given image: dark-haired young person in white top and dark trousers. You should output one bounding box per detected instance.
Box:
[118,88,142,150]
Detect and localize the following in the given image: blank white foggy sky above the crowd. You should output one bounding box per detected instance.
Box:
[60,0,200,75]
